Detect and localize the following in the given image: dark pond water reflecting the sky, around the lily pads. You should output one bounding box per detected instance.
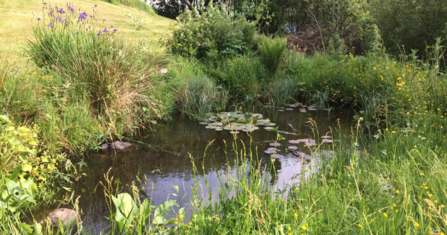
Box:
[39,103,352,231]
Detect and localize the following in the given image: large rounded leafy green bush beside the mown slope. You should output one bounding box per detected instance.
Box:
[167,3,256,59]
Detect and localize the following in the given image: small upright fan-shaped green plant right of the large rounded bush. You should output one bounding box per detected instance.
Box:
[260,37,287,76]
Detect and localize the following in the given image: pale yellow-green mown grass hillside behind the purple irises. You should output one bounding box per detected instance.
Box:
[0,0,175,56]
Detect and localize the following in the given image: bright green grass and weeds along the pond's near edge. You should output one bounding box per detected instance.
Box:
[60,121,447,235]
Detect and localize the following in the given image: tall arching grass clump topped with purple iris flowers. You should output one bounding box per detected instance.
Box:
[28,4,168,136]
